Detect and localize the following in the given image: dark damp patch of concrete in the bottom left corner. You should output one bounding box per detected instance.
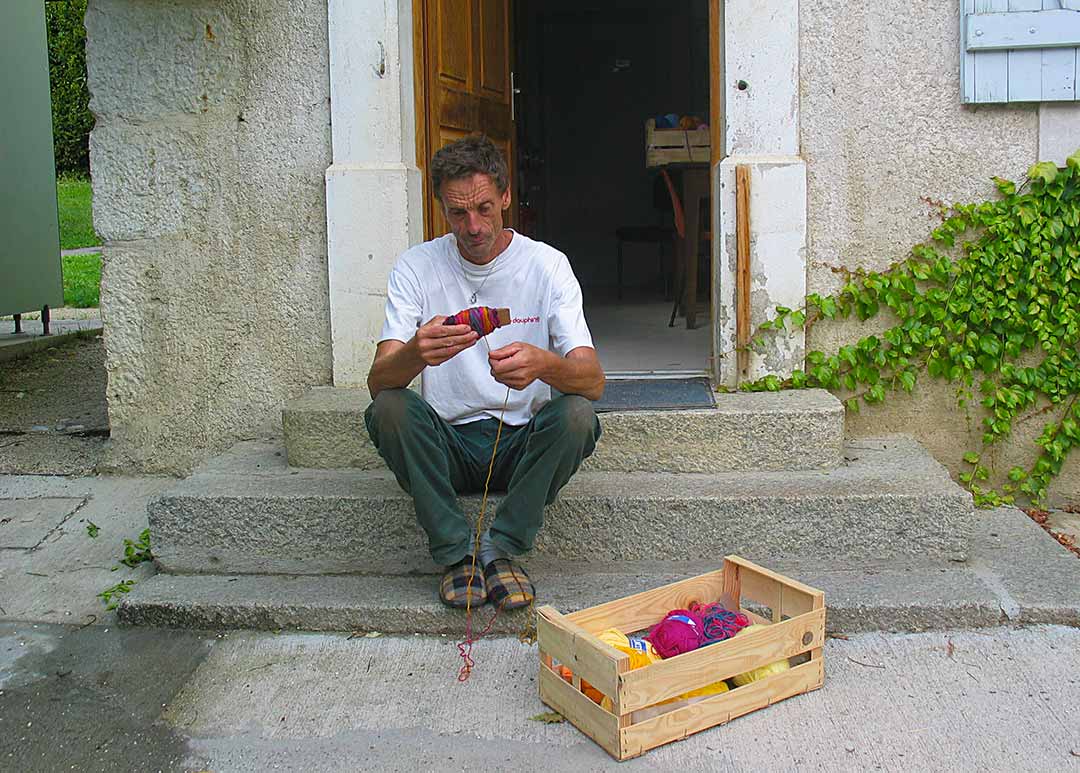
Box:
[0,623,211,771]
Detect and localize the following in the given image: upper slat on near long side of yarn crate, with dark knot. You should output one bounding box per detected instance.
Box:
[617,609,825,714]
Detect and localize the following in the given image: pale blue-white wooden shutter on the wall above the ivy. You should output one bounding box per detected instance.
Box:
[960,0,1080,104]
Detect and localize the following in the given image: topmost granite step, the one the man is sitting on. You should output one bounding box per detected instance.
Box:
[282,387,843,473]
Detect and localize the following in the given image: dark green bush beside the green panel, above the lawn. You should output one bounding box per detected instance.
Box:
[45,0,94,174]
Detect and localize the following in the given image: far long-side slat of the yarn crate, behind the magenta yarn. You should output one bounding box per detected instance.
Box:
[566,570,724,634]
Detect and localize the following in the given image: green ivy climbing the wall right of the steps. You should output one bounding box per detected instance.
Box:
[741,163,1080,506]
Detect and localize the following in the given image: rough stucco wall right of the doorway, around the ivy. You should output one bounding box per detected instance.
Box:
[799,0,1080,501]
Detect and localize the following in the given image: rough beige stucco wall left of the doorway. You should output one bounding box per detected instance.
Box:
[86,0,332,474]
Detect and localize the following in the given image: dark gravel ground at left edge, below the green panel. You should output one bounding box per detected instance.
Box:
[0,336,109,475]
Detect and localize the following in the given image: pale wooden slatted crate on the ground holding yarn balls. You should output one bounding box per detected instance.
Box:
[537,556,825,760]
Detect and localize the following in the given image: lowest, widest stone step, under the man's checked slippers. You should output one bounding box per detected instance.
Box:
[119,508,1080,636]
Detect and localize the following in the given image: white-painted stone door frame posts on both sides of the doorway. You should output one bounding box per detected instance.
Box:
[326,0,807,387]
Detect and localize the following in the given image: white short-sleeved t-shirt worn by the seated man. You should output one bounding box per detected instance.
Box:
[379,232,593,426]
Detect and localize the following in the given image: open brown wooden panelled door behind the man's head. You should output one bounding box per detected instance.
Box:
[417,0,516,239]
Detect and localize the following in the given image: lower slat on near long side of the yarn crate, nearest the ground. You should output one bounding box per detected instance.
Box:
[622,660,825,760]
